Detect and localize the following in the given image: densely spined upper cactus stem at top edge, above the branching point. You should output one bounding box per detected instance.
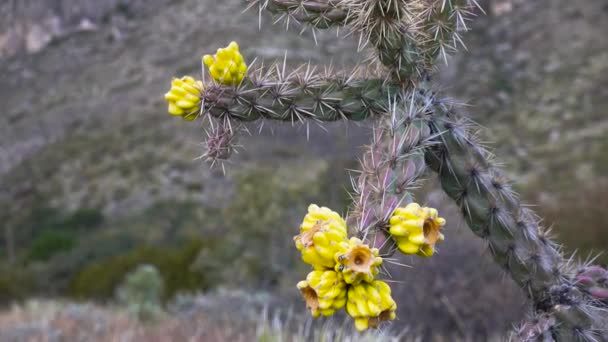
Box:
[344,0,478,84]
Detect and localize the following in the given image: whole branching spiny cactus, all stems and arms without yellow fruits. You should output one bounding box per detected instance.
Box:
[182,0,608,341]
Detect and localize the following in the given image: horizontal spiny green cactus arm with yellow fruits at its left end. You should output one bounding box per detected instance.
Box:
[201,74,393,122]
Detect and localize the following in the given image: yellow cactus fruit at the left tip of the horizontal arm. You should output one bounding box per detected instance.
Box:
[165,76,203,121]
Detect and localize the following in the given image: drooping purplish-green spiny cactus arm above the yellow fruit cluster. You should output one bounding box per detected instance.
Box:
[349,91,430,243]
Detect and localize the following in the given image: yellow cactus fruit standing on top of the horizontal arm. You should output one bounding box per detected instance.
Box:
[203,42,247,85]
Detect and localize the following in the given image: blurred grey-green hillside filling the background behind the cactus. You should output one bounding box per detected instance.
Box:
[0,0,608,339]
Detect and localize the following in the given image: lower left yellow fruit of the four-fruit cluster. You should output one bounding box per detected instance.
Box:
[297,271,346,318]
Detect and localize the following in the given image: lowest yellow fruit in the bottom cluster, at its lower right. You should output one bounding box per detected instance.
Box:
[346,280,397,331]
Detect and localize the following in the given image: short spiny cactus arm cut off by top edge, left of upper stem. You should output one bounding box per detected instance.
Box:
[247,0,350,29]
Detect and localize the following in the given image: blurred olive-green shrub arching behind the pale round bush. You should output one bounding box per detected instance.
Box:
[69,241,212,300]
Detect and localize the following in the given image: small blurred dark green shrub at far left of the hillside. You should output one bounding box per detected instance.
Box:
[27,230,77,261]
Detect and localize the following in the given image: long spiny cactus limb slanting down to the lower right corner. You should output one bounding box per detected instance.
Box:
[426,100,608,341]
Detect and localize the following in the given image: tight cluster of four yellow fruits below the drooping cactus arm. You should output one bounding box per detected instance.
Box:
[294,204,397,330]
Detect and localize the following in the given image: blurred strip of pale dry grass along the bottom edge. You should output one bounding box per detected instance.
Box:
[0,293,500,342]
